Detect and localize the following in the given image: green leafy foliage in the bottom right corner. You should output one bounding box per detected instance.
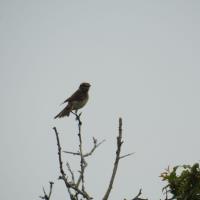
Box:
[161,163,200,200]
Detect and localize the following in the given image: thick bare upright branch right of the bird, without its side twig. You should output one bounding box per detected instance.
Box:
[103,118,123,200]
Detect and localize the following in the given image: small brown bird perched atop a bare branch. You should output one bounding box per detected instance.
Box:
[54,83,90,119]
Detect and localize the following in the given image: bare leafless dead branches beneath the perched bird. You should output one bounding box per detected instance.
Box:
[40,112,147,200]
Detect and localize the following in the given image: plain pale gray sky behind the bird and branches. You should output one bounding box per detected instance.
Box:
[0,0,200,200]
